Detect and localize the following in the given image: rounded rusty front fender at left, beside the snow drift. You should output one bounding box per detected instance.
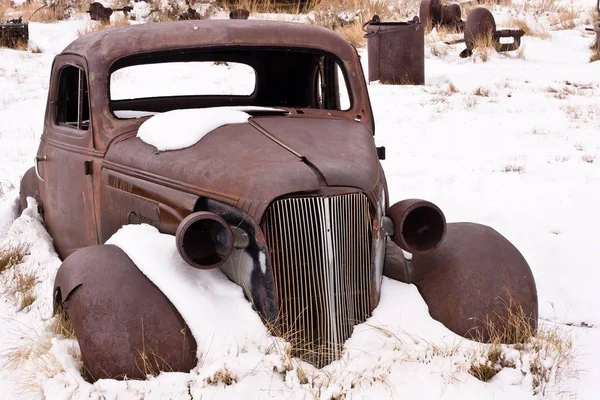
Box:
[54,245,196,381]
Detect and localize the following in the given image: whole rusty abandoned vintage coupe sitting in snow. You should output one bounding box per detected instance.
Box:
[20,20,538,379]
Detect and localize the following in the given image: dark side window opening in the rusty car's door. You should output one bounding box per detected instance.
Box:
[56,65,90,131]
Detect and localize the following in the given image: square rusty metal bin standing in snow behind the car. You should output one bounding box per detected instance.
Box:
[363,16,425,85]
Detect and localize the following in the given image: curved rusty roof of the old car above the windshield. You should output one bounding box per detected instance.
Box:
[62,19,355,67]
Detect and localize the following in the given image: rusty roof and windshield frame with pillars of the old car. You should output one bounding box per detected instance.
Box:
[58,20,374,152]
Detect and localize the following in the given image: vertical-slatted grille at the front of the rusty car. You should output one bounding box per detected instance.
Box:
[263,193,371,367]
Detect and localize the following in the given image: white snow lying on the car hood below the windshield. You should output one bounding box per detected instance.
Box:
[137,107,283,151]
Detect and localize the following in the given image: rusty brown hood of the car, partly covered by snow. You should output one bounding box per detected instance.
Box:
[104,116,381,221]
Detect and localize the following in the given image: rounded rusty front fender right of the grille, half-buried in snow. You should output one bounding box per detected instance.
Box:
[410,222,538,342]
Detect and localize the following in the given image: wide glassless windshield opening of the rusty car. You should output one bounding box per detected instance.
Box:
[109,47,352,119]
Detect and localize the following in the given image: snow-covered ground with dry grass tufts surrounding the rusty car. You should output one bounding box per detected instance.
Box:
[0,0,600,400]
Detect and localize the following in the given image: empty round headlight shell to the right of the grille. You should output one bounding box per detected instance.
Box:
[387,199,446,254]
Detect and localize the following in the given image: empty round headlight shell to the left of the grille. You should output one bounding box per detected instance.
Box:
[175,211,235,269]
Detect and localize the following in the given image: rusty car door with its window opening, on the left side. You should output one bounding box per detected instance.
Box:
[36,55,98,259]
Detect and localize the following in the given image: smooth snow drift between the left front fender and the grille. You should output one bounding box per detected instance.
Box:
[106,224,270,363]
